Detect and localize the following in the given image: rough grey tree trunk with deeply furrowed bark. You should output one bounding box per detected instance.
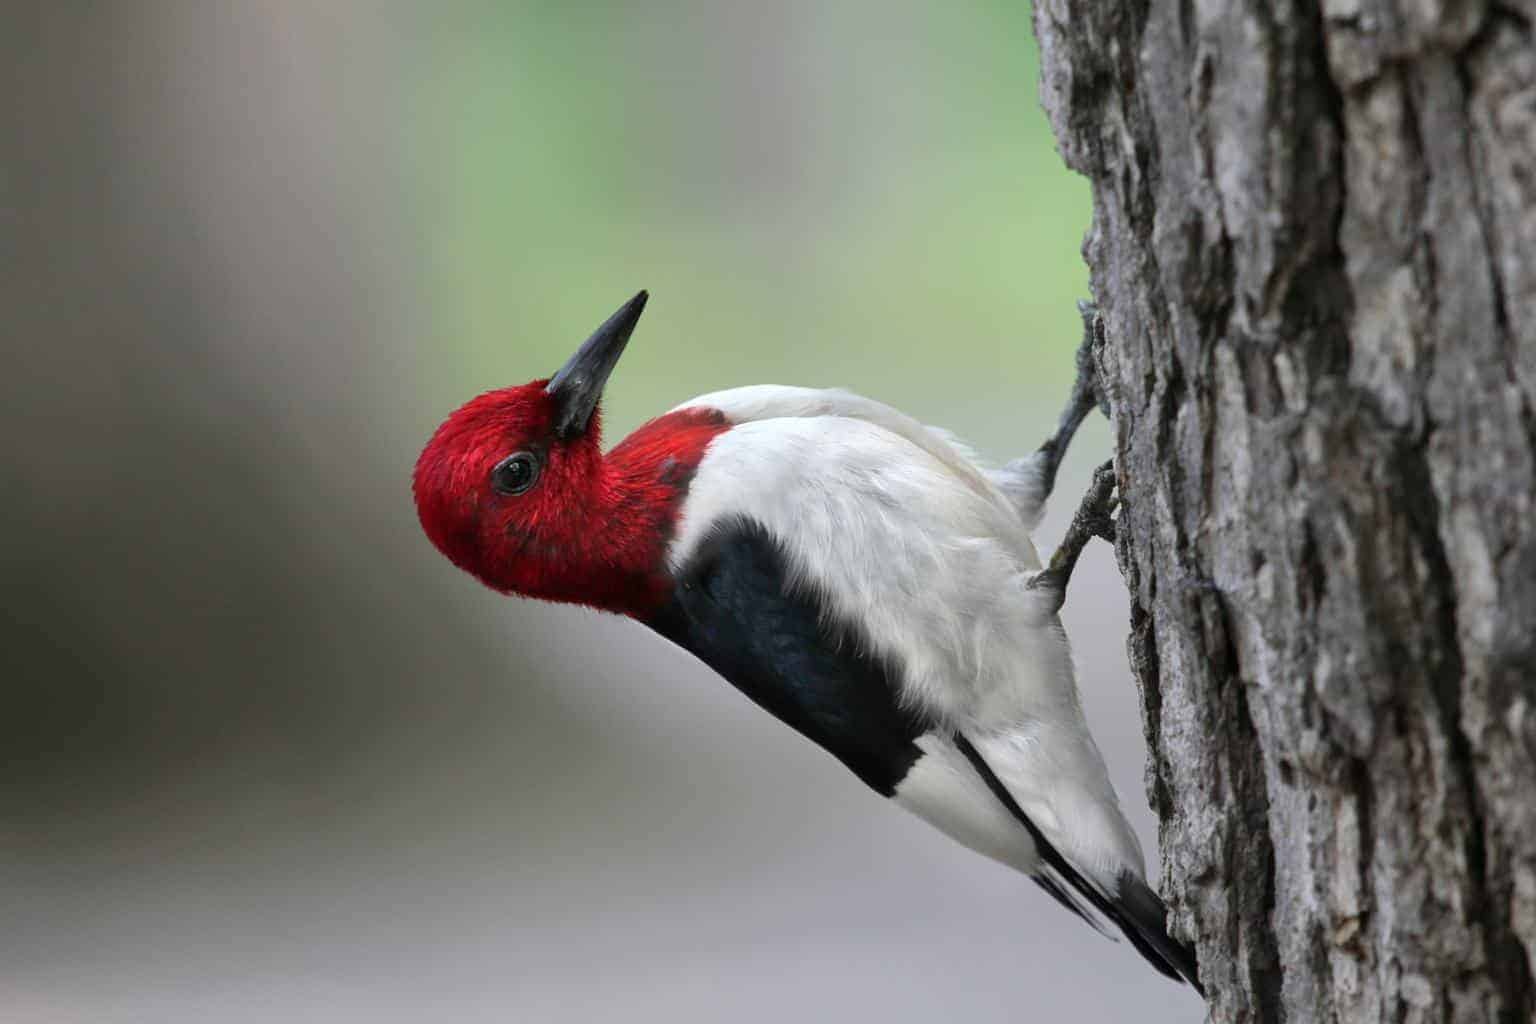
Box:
[1035,0,1536,1022]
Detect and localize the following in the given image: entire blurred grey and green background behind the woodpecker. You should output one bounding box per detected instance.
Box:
[0,0,1200,1024]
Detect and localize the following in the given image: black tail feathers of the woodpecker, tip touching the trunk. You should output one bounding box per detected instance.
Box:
[955,732,1206,998]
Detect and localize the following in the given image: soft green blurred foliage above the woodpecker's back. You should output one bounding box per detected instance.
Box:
[404,3,1089,454]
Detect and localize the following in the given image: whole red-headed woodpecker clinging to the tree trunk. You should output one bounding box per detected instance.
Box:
[413,292,1200,990]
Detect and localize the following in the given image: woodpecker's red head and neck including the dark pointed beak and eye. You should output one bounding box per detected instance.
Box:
[415,292,719,617]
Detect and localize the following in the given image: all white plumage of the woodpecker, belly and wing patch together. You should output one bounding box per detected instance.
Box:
[670,387,1143,881]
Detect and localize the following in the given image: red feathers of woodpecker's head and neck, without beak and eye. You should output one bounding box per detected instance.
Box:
[415,399,730,620]
